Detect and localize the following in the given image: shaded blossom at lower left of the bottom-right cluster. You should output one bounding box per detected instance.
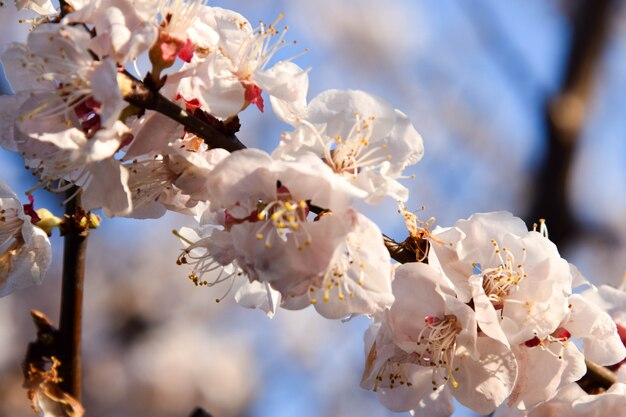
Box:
[362,263,517,416]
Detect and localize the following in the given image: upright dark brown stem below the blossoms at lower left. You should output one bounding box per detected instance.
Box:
[58,187,89,401]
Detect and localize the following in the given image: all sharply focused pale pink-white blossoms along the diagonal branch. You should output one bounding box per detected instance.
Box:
[0,0,626,416]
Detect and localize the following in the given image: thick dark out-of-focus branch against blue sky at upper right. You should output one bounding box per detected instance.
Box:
[527,0,615,247]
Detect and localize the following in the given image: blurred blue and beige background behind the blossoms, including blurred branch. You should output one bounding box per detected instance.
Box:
[0,0,626,417]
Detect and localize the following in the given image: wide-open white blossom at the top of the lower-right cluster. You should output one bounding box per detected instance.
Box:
[429,212,573,345]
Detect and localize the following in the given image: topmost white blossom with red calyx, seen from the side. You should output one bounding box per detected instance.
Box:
[170,7,308,119]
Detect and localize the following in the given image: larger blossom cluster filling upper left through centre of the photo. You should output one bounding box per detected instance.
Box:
[0,0,423,318]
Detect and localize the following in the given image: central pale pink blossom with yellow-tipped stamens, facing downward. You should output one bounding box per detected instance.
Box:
[202,149,359,296]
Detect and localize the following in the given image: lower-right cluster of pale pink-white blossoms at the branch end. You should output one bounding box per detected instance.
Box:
[362,212,626,416]
